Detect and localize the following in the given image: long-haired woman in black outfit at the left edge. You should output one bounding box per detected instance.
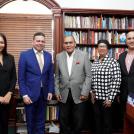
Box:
[0,33,16,134]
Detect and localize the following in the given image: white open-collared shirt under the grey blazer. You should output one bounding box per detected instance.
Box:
[66,51,75,76]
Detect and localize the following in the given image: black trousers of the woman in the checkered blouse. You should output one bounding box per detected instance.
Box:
[92,100,112,134]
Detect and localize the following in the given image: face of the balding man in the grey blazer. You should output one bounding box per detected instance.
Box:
[63,36,76,56]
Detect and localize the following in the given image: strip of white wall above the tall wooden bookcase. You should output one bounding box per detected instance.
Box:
[55,0,134,10]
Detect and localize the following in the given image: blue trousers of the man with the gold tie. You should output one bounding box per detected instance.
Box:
[25,90,47,134]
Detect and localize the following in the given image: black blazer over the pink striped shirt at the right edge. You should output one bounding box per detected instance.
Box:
[119,51,134,101]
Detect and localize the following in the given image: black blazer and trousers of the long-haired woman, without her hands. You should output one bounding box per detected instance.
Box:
[0,54,16,134]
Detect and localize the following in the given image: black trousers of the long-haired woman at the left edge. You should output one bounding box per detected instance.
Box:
[0,104,11,134]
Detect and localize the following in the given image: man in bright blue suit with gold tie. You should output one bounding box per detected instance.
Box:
[18,33,54,134]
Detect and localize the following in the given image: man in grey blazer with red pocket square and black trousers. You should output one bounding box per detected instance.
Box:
[55,36,91,134]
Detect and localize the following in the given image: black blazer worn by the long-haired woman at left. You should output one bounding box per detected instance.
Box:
[0,54,16,96]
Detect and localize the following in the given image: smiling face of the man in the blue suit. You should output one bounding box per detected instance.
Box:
[32,35,45,52]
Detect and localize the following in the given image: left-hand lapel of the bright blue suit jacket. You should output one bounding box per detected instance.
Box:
[30,49,41,73]
